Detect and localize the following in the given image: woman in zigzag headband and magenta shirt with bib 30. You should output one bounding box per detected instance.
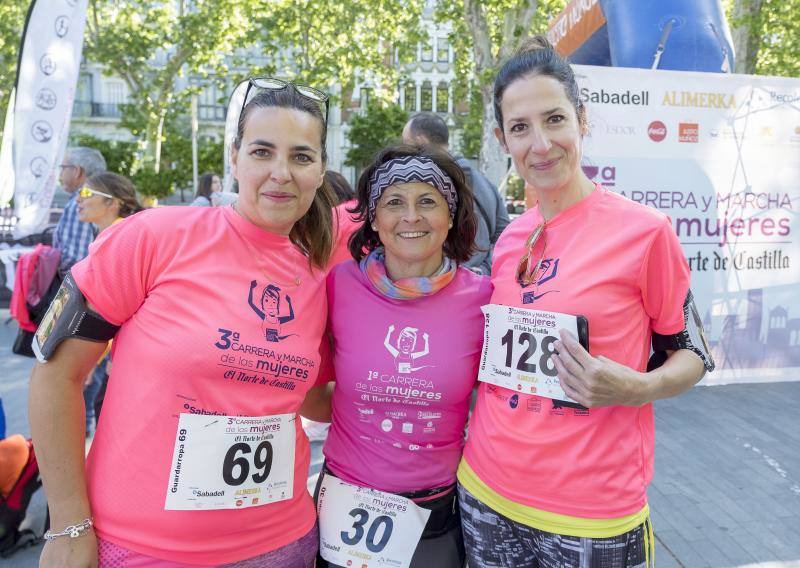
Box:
[310,146,490,568]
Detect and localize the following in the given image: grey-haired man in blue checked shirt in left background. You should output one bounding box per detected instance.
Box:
[53,146,106,274]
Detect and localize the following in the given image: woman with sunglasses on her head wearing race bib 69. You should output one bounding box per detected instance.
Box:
[30,79,333,568]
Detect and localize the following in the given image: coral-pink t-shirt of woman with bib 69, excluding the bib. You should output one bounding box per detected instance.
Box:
[72,207,327,564]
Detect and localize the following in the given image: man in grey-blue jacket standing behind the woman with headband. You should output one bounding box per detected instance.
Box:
[403,113,509,274]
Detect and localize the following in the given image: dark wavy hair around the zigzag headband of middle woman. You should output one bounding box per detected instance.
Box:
[348,144,478,262]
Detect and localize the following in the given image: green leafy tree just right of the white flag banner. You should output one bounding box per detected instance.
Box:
[84,0,248,173]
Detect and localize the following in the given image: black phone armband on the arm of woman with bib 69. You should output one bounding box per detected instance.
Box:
[32,273,119,363]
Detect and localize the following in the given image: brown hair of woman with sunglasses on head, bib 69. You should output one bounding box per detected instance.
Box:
[233,85,337,268]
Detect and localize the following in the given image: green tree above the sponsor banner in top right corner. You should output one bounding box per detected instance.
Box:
[723,0,800,77]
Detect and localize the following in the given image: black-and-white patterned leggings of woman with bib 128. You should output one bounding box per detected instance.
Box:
[458,484,655,568]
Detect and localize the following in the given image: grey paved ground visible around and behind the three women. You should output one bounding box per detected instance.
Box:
[0,310,800,568]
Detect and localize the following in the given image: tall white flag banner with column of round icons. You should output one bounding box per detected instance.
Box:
[9,0,88,238]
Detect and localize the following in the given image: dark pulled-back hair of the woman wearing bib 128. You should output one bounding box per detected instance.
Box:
[494,34,588,132]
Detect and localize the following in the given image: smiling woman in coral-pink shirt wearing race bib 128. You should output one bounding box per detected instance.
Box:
[458,36,713,568]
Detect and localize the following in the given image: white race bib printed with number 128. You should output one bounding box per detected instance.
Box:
[478,304,588,404]
